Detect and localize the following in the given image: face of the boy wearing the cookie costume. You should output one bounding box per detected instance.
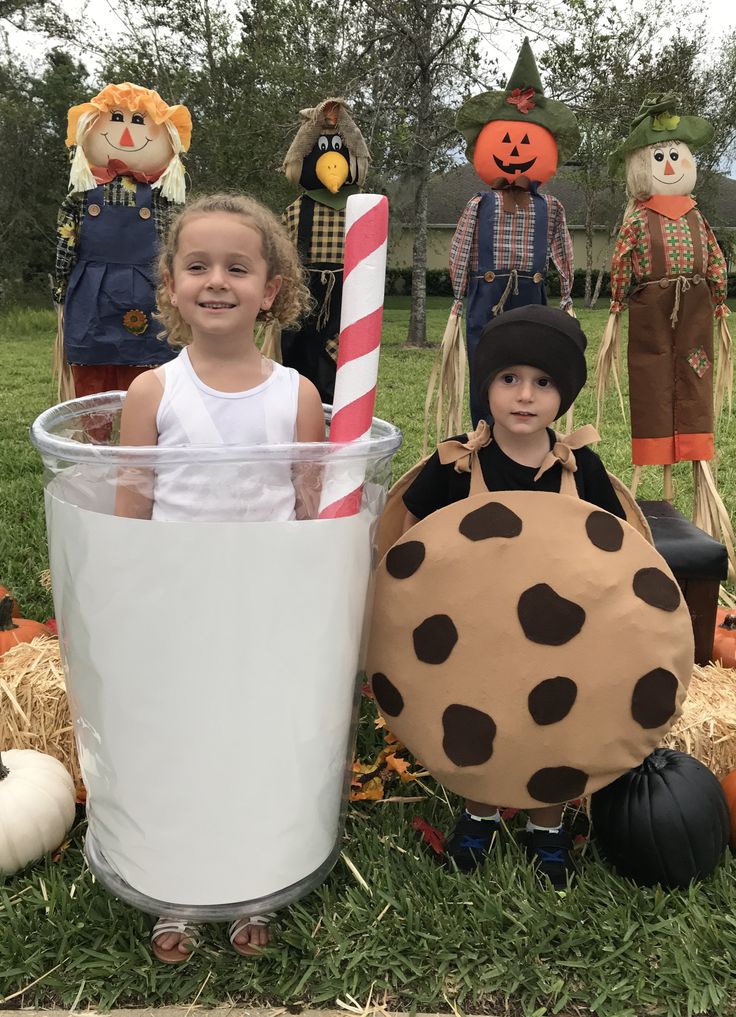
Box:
[488,364,560,435]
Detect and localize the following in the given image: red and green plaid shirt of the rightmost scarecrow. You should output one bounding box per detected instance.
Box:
[611,201,728,317]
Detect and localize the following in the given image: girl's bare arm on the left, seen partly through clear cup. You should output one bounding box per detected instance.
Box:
[115,371,164,519]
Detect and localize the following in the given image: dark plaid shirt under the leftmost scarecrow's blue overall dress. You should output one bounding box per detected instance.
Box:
[53,177,176,304]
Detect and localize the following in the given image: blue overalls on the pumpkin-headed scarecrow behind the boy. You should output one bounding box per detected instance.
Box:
[466,188,549,427]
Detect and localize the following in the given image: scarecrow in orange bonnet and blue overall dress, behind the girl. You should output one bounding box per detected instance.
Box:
[54,81,191,397]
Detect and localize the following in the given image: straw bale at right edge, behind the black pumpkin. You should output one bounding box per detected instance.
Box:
[662,664,736,778]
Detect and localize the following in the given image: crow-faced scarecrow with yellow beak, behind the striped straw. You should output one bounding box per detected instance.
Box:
[282,99,370,403]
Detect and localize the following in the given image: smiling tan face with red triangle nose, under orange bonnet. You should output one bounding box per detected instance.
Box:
[82,107,174,173]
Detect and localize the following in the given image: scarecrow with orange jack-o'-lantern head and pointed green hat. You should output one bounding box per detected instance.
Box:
[430,39,580,433]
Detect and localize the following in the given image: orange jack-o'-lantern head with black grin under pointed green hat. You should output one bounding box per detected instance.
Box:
[473,120,557,184]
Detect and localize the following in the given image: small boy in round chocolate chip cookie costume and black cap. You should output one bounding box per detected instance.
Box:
[368,306,692,888]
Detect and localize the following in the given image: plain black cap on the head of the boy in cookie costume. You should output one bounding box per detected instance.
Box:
[473,304,588,419]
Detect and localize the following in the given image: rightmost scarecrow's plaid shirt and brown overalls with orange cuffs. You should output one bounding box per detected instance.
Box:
[611,199,727,466]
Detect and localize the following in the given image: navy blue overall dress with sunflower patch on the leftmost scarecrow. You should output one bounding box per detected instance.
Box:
[64,183,178,366]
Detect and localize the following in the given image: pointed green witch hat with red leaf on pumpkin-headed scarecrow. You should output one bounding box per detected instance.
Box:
[455,39,580,165]
